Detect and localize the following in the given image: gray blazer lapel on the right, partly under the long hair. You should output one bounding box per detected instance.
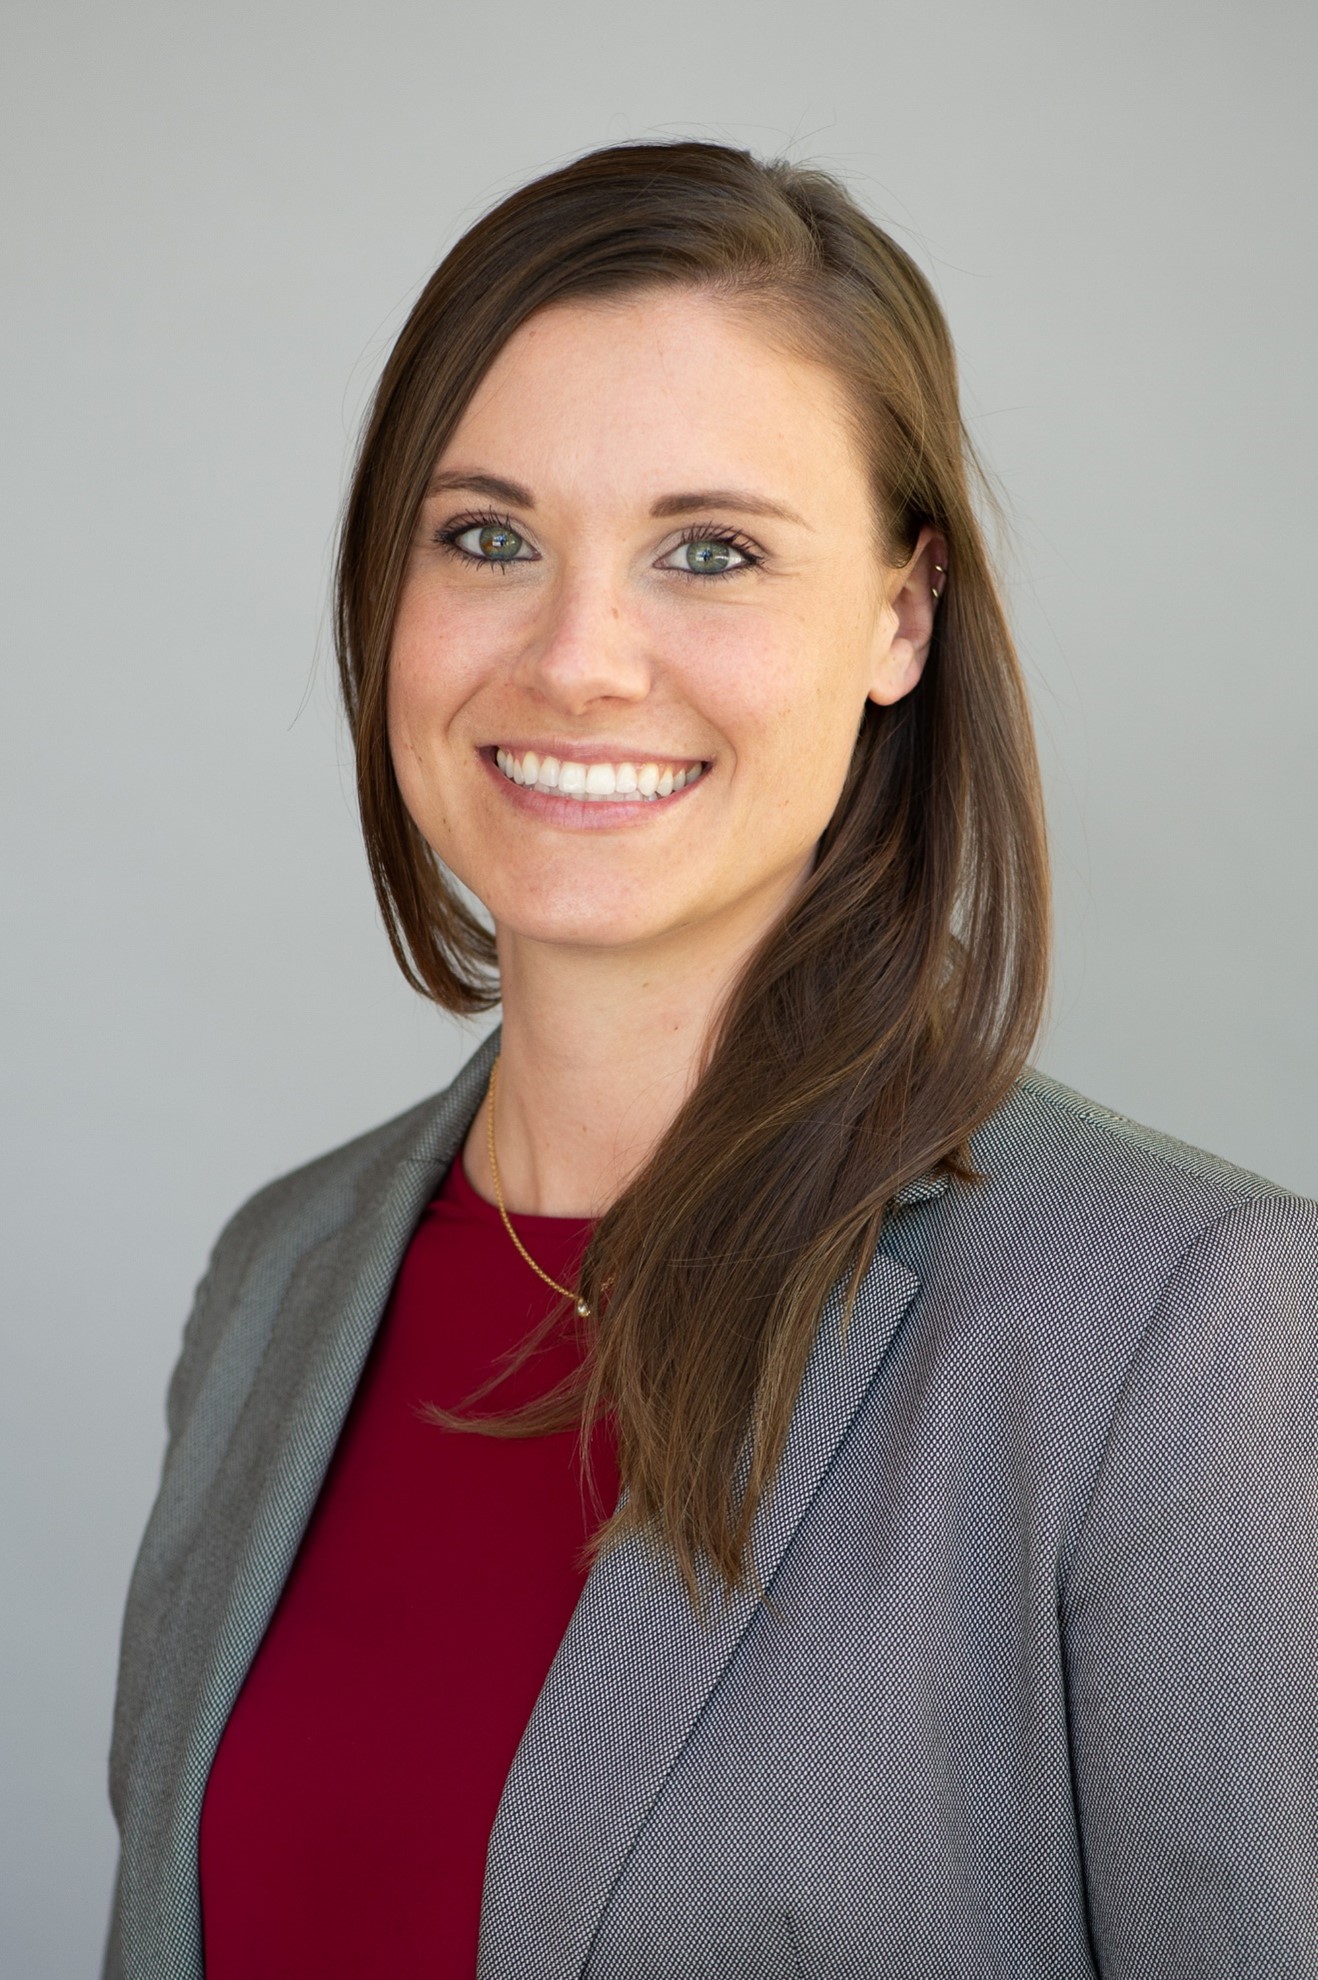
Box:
[477,1203,922,1980]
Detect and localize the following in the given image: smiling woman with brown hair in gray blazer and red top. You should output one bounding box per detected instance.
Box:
[107,145,1318,1980]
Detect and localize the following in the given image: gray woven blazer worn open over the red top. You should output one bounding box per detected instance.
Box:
[105,1040,1318,1980]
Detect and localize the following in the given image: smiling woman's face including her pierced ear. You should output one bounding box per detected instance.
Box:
[388,289,942,966]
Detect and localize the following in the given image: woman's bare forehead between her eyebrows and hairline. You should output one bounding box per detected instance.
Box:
[441,289,867,509]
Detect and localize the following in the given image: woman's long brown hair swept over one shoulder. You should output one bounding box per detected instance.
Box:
[334,143,1049,1606]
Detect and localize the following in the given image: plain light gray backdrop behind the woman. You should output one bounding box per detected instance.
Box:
[0,0,1318,1980]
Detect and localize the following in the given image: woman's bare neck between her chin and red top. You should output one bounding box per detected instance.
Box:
[463,901,782,1218]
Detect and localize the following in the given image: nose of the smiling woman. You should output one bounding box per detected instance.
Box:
[513,568,653,715]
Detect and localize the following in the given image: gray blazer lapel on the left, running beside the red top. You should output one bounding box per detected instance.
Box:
[123,1034,499,1980]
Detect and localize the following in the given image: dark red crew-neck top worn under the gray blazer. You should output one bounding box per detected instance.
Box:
[202,1158,617,1980]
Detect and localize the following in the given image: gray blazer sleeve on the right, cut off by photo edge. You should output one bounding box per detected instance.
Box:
[1061,1196,1318,1980]
